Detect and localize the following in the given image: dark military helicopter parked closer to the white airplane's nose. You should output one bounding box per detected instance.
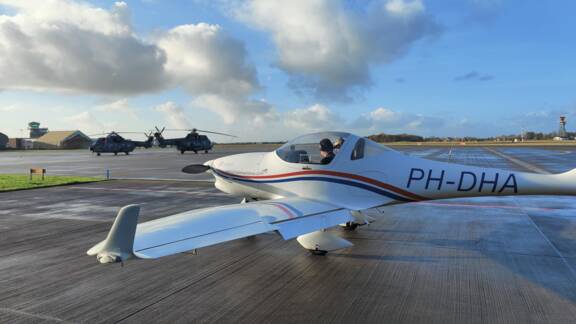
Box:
[154,127,236,154]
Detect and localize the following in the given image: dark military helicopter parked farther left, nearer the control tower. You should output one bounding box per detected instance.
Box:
[90,132,154,156]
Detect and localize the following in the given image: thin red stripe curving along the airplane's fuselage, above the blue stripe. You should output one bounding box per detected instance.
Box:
[218,169,428,200]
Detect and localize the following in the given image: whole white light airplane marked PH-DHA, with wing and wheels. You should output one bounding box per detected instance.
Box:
[87,132,576,263]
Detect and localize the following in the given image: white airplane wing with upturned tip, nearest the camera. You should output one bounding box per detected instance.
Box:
[87,198,354,263]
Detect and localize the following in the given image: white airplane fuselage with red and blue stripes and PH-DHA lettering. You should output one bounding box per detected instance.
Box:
[206,132,574,209]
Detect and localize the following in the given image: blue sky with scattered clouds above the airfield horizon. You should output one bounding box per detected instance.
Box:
[0,0,576,142]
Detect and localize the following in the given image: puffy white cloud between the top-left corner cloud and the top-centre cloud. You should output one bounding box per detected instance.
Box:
[158,23,274,124]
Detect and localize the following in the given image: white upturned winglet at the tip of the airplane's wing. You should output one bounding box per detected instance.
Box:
[86,205,140,263]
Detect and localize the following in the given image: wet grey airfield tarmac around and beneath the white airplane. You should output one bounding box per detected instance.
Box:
[0,147,576,323]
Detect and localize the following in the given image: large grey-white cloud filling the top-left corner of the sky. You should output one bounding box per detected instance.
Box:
[0,0,165,94]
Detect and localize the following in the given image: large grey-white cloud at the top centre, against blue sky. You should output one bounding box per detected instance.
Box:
[232,0,439,99]
